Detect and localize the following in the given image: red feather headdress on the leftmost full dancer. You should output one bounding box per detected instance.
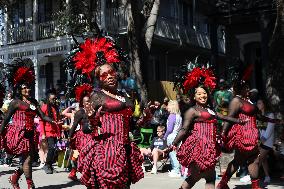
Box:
[13,66,35,87]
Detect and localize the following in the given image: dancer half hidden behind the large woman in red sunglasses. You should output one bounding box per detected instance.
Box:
[68,84,93,180]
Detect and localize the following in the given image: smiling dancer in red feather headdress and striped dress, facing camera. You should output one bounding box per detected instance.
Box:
[172,63,244,189]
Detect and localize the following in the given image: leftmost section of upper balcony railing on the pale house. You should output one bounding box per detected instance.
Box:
[7,25,33,44]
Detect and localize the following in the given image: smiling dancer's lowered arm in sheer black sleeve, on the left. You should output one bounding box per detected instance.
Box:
[173,108,196,147]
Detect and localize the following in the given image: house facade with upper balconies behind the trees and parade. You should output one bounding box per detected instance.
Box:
[0,0,226,99]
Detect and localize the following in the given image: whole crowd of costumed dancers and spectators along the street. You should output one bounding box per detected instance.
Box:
[0,37,284,189]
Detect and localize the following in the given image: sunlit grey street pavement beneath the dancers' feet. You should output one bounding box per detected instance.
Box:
[0,167,284,189]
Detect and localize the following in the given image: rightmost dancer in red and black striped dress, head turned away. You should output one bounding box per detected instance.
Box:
[217,78,282,189]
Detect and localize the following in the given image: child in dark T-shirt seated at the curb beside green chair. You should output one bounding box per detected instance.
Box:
[140,125,167,174]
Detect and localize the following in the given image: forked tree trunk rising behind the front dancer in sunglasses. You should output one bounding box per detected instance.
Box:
[125,0,160,105]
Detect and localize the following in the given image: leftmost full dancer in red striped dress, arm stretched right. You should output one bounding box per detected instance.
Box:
[0,59,56,189]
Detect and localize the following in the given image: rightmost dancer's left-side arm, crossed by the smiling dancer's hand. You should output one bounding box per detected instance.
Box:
[221,98,242,135]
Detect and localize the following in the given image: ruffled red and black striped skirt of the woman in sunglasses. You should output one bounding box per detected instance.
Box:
[78,139,144,189]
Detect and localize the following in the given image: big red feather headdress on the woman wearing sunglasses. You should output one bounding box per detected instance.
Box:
[73,37,120,76]
